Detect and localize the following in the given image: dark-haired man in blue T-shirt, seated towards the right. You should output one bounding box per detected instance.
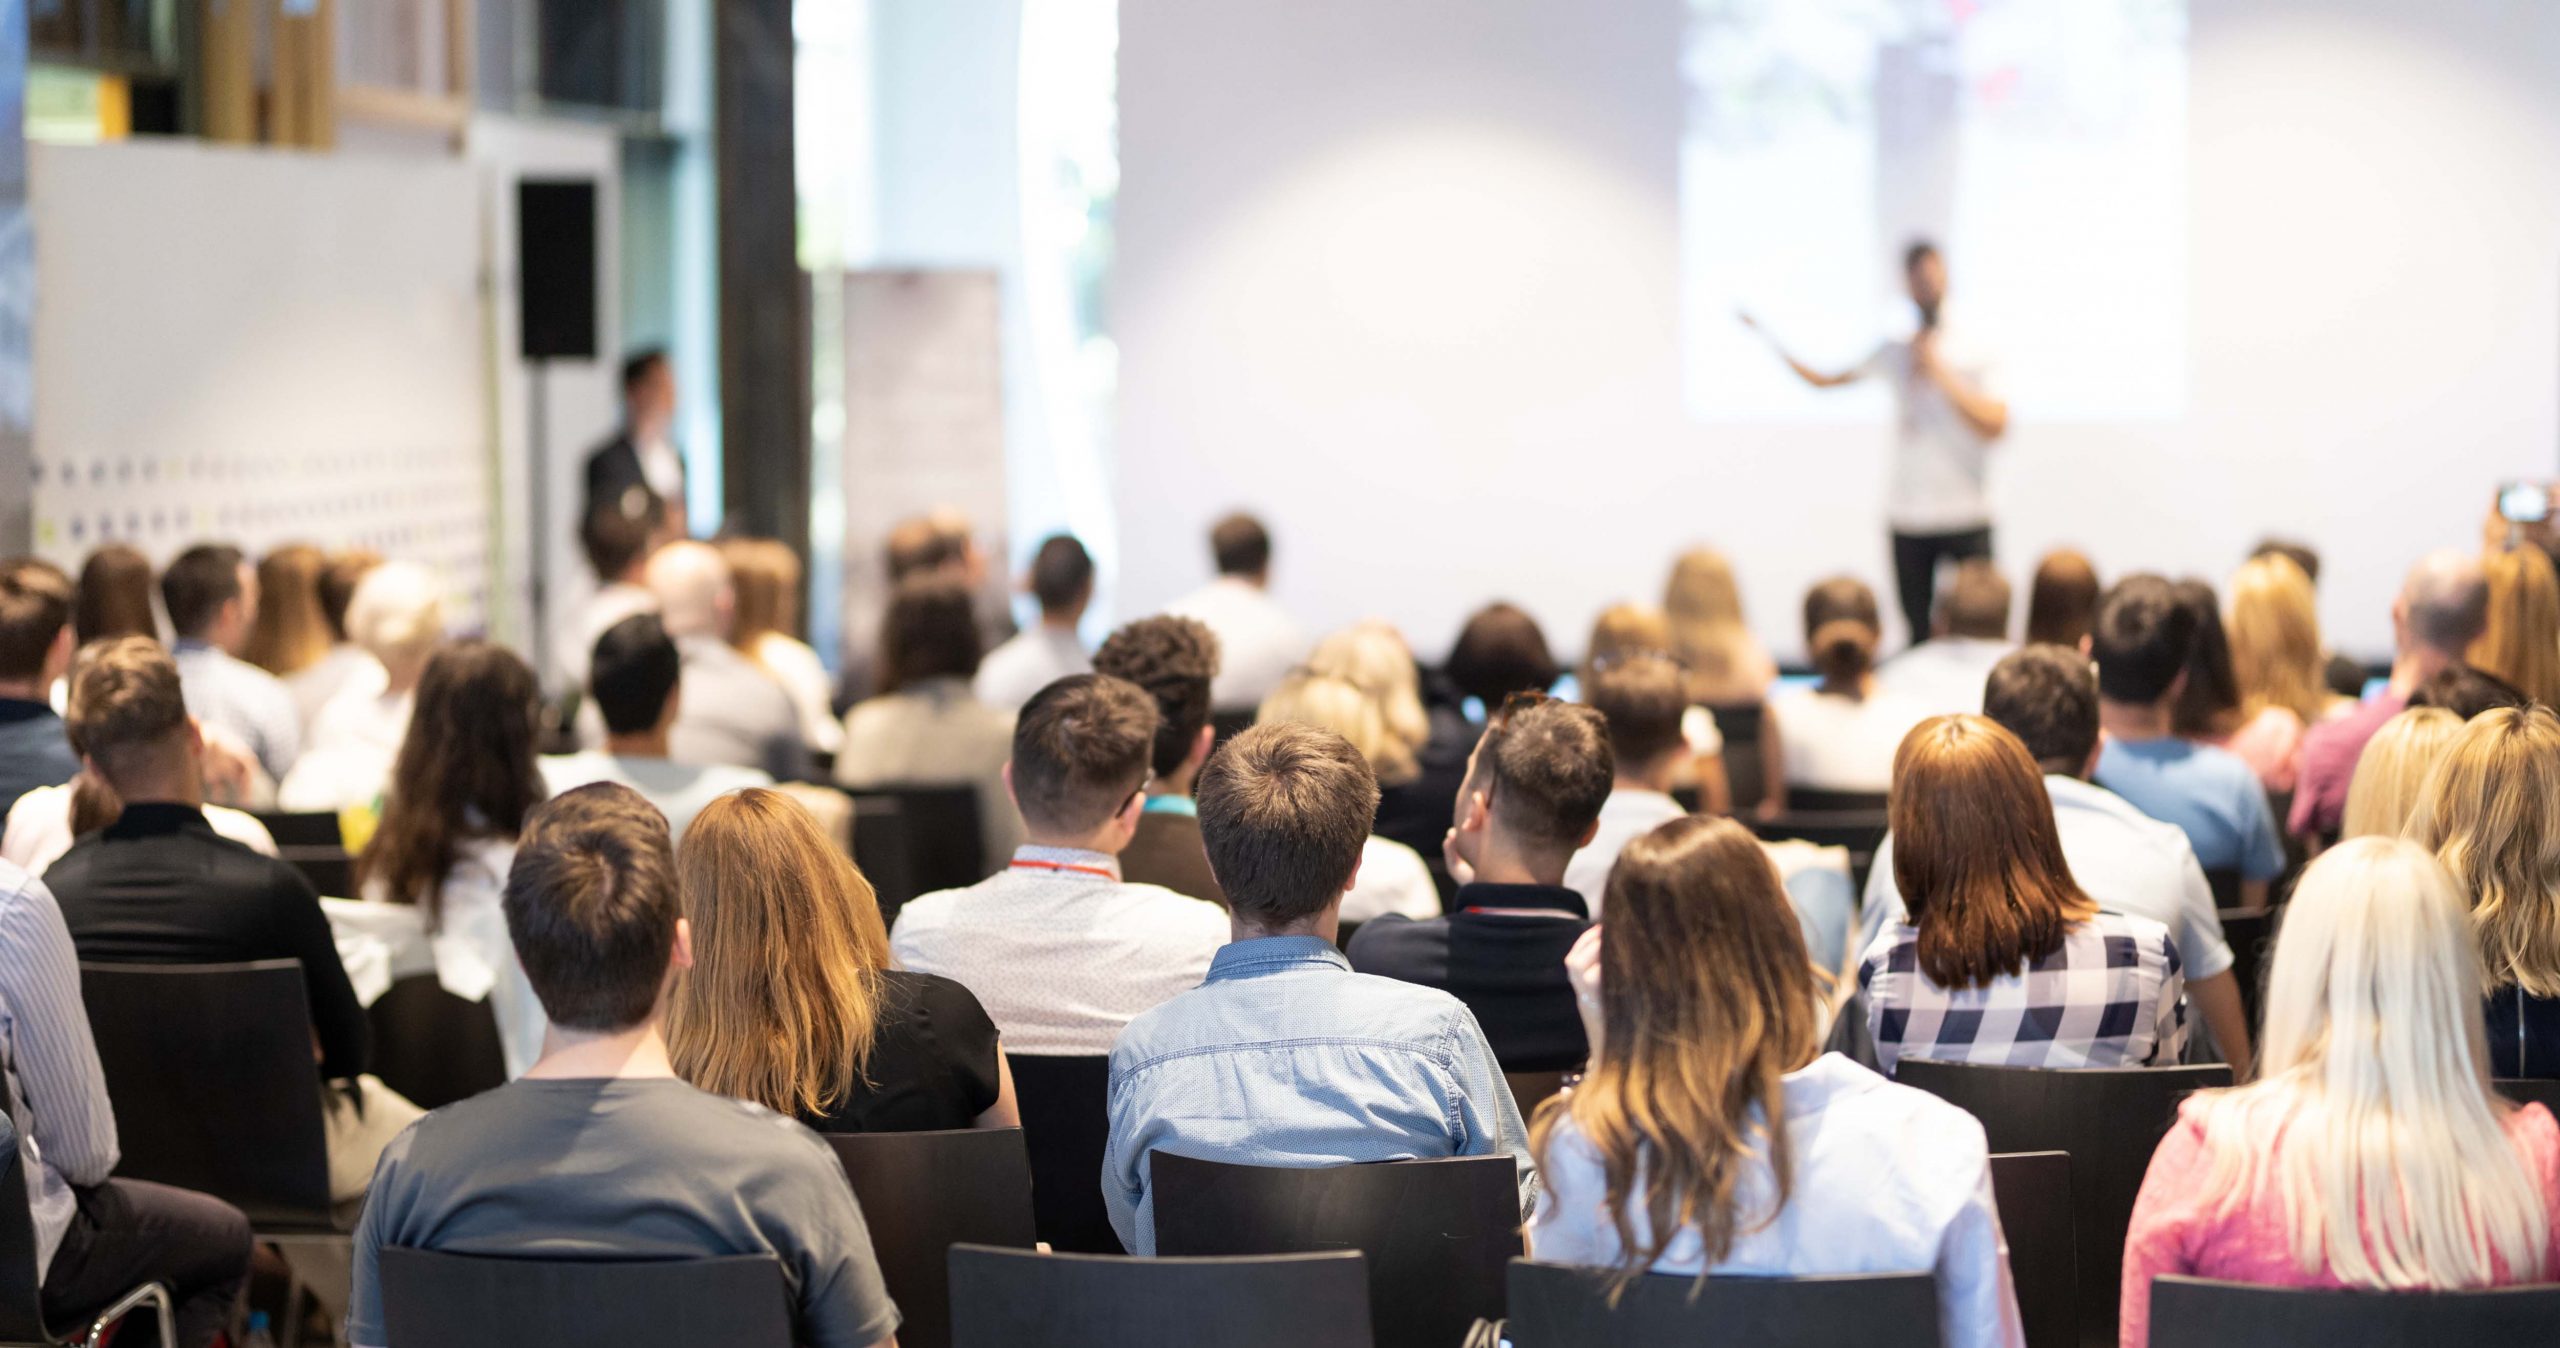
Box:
[2089,576,2284,908]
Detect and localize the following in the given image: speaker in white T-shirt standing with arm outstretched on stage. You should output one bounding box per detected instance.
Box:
[1743,238,2010,642]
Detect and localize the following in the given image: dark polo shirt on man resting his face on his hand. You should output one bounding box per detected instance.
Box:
[1347,885,1590,1072]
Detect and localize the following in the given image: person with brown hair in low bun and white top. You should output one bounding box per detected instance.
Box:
[1769,576,1928,795]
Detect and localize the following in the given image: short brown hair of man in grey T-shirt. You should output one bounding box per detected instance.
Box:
[504,783,678,1031]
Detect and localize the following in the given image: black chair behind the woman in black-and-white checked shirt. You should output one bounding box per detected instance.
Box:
[1894,1059,2232,1343]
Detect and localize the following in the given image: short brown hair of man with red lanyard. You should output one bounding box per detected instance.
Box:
[1014,675,1160,834]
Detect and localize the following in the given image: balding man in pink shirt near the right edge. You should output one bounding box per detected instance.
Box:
[2291,553,2488,836]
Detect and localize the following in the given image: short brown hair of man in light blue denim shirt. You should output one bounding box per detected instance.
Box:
[1198,724,1377,926]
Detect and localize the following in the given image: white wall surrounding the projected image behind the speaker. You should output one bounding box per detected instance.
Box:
[1131,0,2560,652]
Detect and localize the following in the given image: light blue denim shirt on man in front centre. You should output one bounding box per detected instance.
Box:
[1101,936,1539,1256]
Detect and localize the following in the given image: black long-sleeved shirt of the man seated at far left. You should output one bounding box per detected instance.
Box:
[44,803,366,1077]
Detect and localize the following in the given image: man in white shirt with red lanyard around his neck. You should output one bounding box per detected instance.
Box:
[888,675,1234,1056]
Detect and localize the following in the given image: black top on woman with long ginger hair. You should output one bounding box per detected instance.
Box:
[801,969,1001,1133]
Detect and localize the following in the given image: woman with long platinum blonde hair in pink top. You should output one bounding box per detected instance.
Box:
[2120,836,2560,1348]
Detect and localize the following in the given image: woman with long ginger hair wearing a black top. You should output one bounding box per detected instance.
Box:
[668,788,1019,1133]
